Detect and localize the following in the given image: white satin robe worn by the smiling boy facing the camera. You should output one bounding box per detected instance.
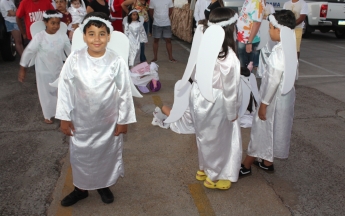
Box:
[56,48,136,190]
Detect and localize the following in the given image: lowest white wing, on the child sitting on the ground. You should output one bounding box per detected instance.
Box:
[164,80,192,123]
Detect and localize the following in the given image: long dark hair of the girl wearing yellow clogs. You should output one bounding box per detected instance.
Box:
[204,7,236,59]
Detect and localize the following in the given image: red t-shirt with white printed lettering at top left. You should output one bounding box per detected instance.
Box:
[16,0,55,40]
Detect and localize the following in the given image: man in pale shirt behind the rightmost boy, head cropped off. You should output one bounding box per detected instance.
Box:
[283,0,308,59]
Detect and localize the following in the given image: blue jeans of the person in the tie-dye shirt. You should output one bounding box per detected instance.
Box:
[236,41,260,67]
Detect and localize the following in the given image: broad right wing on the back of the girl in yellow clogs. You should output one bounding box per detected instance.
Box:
[195,25,225,103]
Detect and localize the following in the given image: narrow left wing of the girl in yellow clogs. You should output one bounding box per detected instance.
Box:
[178,25,203,89]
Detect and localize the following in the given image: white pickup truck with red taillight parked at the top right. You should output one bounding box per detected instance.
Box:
[223,0,345,38]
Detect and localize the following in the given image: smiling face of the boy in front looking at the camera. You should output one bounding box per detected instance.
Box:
[83,25,110,57]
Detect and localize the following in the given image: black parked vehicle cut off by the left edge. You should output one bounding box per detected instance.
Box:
[0,13,17,61]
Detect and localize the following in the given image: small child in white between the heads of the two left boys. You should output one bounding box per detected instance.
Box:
[68,0,86,40]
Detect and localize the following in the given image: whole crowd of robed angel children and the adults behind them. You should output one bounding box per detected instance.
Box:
[0,0,307,206]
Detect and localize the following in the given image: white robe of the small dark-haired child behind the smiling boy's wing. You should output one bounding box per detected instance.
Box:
[125,21,147,66]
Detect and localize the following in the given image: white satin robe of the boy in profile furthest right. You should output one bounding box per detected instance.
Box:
[248,43,295,162]
